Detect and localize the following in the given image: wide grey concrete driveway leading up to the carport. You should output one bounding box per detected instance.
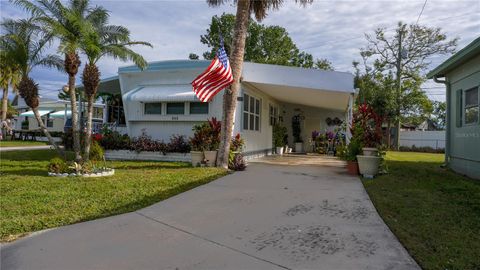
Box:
[1,157,418,270]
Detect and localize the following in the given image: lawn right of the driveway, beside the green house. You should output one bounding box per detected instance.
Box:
[363,152,480,270]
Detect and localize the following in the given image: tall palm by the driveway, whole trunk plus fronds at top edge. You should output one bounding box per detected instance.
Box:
[207,0,313,168]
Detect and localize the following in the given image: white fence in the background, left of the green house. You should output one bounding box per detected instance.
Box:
[400,130,445,149]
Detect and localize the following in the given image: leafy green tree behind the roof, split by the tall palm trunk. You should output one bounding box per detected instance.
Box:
[200,13,329,68]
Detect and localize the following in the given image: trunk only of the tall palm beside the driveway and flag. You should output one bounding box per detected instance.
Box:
[217,0,250,169]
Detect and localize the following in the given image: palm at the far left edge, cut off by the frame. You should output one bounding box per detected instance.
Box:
[0,51,21,121]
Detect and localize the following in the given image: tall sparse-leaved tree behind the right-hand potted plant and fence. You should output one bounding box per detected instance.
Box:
[361,22,457,149]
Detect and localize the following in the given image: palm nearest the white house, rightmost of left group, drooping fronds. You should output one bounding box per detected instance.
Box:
[82,21,152,161]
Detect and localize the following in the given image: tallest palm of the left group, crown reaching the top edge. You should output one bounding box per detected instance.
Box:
[13,0,108,162]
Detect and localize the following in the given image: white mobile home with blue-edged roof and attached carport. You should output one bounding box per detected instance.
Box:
[95,60,354,156]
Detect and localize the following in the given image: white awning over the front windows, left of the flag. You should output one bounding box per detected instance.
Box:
[124,84,198,102]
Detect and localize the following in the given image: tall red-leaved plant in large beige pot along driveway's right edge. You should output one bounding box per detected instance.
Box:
[353,104,382,178]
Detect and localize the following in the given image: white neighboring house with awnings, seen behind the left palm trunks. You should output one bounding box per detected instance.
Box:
[14,98,105,132]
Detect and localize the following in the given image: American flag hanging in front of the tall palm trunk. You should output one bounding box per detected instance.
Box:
[192,39,233,102]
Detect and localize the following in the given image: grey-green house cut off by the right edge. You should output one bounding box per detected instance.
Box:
[428,37,480,179]
